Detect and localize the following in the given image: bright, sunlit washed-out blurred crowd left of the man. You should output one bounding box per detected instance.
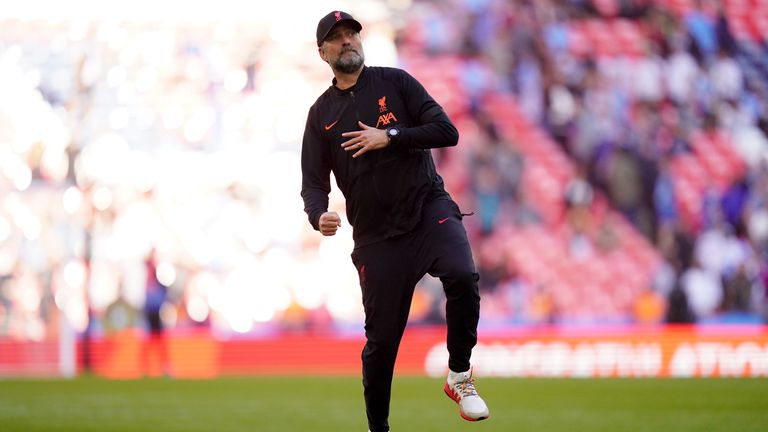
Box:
[0,7,376,340]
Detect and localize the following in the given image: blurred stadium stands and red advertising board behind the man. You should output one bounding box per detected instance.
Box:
[0,0,768,378]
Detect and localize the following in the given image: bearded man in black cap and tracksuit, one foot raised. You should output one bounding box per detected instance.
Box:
[301,11,489,432]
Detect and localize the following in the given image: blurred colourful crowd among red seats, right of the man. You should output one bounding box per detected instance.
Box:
[402,0,768,323]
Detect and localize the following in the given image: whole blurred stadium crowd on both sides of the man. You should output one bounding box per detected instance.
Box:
[0,0,768,340]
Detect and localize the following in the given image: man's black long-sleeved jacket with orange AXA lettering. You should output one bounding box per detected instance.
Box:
[301,67,459,247]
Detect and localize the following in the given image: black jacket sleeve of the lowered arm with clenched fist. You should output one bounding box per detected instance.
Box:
[301,109,331,231]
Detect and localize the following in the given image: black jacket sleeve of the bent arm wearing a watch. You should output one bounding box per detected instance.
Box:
[395,71,459,149]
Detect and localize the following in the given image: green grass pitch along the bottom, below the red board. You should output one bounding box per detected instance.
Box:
[0,377,768,432]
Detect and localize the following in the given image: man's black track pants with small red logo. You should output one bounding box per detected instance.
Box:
[352,200,480,432]
